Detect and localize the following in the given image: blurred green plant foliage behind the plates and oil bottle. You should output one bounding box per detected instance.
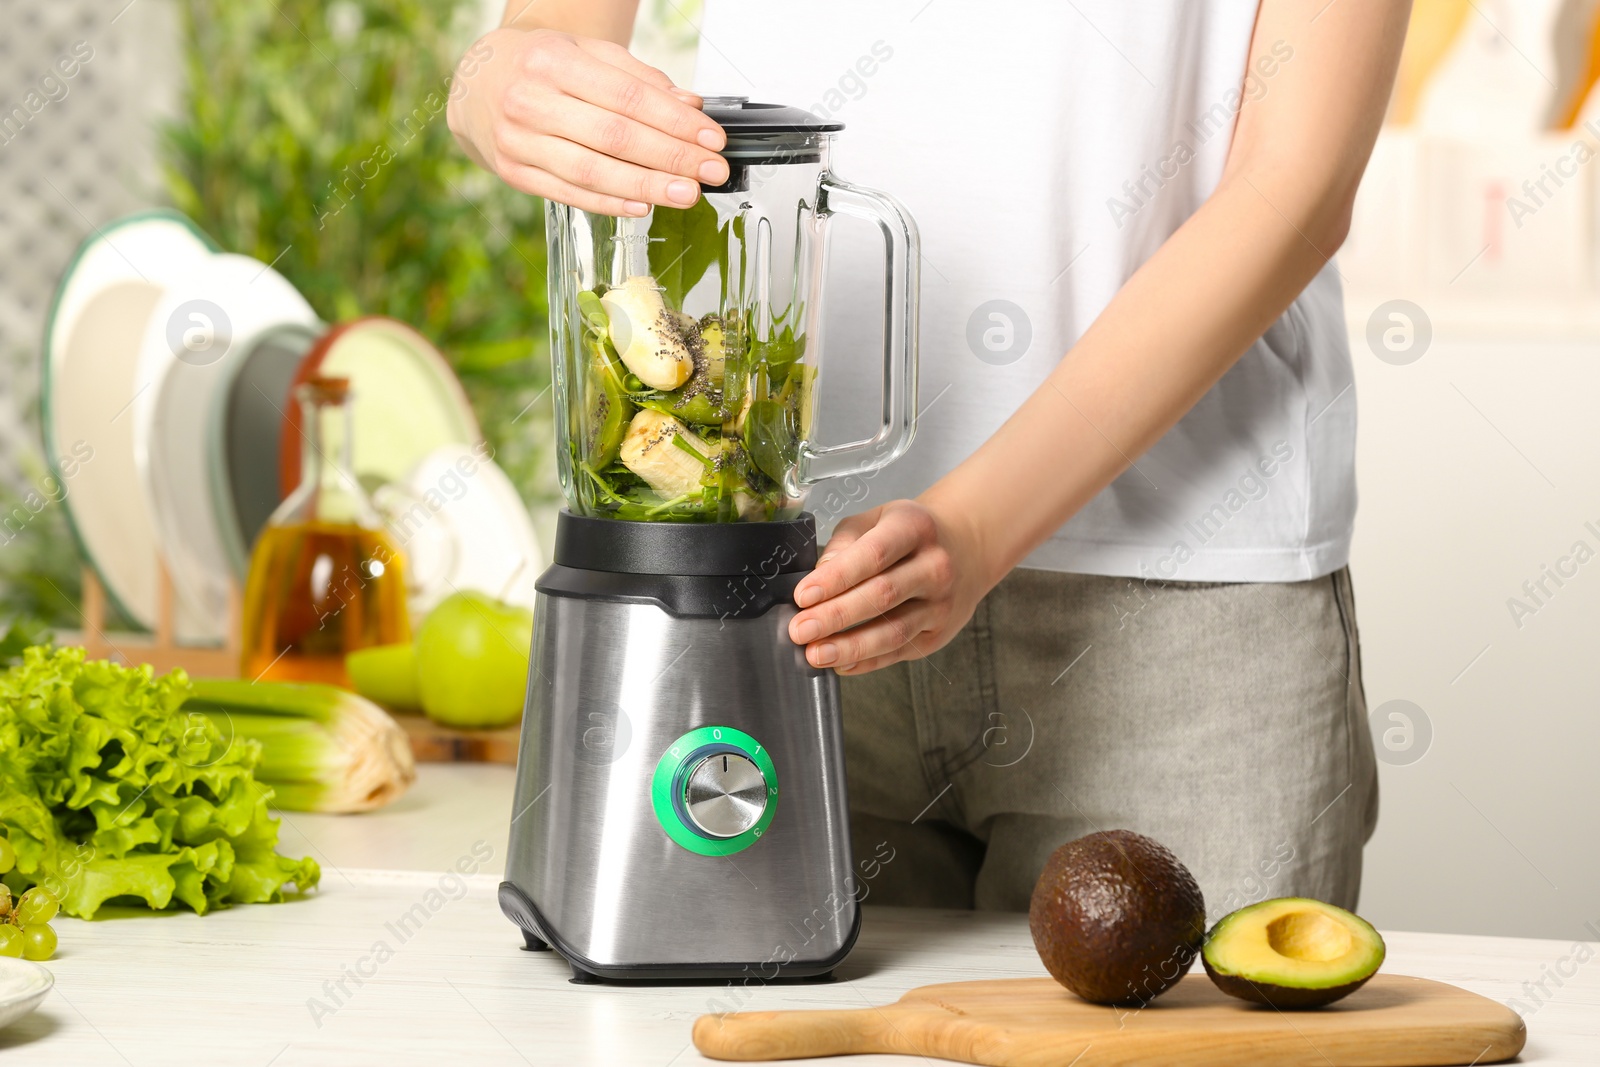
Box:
[163,0,554,504]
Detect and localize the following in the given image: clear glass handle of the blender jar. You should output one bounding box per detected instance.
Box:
[800,174,922,485]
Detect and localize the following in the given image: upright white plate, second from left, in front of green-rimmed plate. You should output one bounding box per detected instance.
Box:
[130,254,320,643]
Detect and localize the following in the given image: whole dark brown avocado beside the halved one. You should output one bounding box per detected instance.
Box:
[1027,830,1205,1006]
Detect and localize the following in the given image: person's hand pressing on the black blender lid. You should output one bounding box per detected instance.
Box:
[448,27,728,216]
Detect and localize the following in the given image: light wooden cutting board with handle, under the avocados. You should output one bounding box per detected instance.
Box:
[694,973,1528,1067]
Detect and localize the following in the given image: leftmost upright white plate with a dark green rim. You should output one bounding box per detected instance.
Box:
[40,211,213,627]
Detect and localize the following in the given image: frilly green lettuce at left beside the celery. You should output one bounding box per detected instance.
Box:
[0,648,320,918]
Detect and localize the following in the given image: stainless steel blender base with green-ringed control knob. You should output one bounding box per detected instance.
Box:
[501,518,859,981]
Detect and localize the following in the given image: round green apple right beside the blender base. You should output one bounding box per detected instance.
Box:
[416,592,533,726]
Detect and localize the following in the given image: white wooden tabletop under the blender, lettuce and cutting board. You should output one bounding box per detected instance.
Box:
[0,768,1600,1067]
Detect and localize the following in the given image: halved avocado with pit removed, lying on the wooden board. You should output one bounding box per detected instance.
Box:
[1200,896,1384,1009]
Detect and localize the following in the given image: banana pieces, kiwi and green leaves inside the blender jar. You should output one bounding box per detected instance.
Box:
[566,278,814,522]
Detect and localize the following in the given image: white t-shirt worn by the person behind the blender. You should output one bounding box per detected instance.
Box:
[694,0,1355,581]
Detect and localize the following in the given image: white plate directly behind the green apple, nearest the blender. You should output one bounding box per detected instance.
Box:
[373,445,544,614]
